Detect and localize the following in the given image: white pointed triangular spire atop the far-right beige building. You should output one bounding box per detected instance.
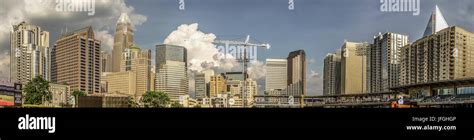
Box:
[423,5,449,37]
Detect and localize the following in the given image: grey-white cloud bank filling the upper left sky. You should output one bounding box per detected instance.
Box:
[0,0,147,80]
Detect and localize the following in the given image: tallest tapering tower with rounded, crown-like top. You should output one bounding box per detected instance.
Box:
[111,13,134,72]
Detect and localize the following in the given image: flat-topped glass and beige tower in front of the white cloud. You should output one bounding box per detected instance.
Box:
[155,44,189,101]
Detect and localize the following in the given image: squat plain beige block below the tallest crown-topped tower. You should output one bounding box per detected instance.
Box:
[104,71,137,97]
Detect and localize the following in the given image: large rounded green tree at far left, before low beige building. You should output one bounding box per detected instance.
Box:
[23,75,52,105]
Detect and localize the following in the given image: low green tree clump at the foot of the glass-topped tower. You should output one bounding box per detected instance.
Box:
[140,91,170,108]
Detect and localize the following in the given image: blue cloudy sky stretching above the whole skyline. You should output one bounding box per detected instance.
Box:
[0,0,474,95]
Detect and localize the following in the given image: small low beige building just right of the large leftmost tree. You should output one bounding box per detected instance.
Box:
[49,83,72,107]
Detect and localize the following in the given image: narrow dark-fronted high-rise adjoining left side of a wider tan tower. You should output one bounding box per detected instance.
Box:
[323,49,341,95]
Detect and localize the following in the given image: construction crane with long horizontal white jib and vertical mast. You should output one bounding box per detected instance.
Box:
[214,35,271,107]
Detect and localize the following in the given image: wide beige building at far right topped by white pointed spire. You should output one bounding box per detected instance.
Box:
[399,6,474,86]
